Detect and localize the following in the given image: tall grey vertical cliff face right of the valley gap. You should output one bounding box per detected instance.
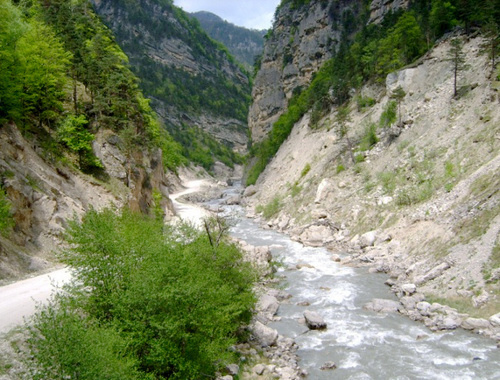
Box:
[248,0,408,142]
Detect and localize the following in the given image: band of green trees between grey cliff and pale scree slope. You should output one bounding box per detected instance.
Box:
[247,0,500,184]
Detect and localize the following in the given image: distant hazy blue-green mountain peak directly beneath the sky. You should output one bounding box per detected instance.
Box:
[191,11,266,72]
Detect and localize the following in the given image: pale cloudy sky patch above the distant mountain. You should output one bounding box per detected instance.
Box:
[174,0,280,30]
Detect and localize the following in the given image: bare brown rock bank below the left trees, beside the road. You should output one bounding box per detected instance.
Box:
[0,124,172,281]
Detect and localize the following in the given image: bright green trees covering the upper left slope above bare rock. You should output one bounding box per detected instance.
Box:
[0,0,182,172]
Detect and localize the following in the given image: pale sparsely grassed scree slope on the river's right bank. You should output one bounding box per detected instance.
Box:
[247,35,500,338]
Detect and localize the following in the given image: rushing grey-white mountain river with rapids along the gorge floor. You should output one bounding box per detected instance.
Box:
[207,189,500,380]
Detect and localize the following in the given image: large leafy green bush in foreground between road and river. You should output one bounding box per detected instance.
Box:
[27,210,256,379]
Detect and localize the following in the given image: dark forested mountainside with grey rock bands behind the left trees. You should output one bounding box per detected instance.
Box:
[92,0,250,152]
